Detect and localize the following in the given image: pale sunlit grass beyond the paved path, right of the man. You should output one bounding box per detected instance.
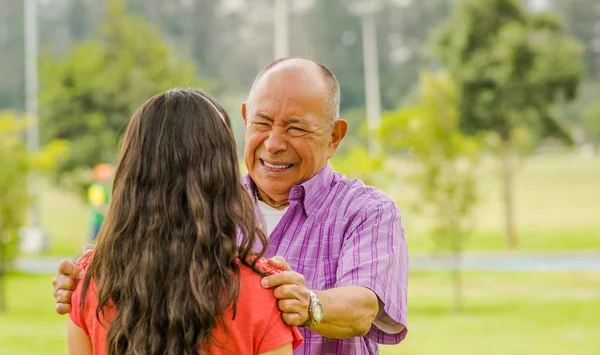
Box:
[386,153,600,251]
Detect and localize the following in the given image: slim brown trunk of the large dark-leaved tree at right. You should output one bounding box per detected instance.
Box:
[502,139,517,249]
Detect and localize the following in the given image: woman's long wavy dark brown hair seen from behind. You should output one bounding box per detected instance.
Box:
[82,89,267,355]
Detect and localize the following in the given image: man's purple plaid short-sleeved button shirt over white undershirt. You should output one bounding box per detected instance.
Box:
[243,164,408,355]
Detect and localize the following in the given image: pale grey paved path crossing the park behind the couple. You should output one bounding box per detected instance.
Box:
[16,250,600,274]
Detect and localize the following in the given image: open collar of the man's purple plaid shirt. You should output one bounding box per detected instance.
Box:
[242,162,333,215]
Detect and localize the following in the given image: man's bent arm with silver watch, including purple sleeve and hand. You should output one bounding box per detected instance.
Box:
[263,202,408,344]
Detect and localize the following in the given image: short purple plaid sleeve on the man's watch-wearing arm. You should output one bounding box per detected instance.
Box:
[335,202,408,344]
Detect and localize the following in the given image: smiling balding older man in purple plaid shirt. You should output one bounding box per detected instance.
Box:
[54,58,408,355]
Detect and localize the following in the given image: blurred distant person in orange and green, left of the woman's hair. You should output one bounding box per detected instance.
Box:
[87,164,112,242]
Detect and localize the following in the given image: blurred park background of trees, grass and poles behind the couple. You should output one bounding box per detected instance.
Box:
[0,0,600,355]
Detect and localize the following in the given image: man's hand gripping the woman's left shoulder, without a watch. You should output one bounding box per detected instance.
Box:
[52,245,94,315]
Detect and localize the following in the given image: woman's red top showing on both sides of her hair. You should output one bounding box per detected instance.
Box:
[69,253,302,355]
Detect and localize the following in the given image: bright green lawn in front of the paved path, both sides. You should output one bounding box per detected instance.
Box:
[0,271,600,355]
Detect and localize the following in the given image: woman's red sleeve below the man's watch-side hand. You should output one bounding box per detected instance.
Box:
[257,302,304,353]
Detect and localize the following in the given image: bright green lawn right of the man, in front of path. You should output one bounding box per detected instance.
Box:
[383,272,600,355]
